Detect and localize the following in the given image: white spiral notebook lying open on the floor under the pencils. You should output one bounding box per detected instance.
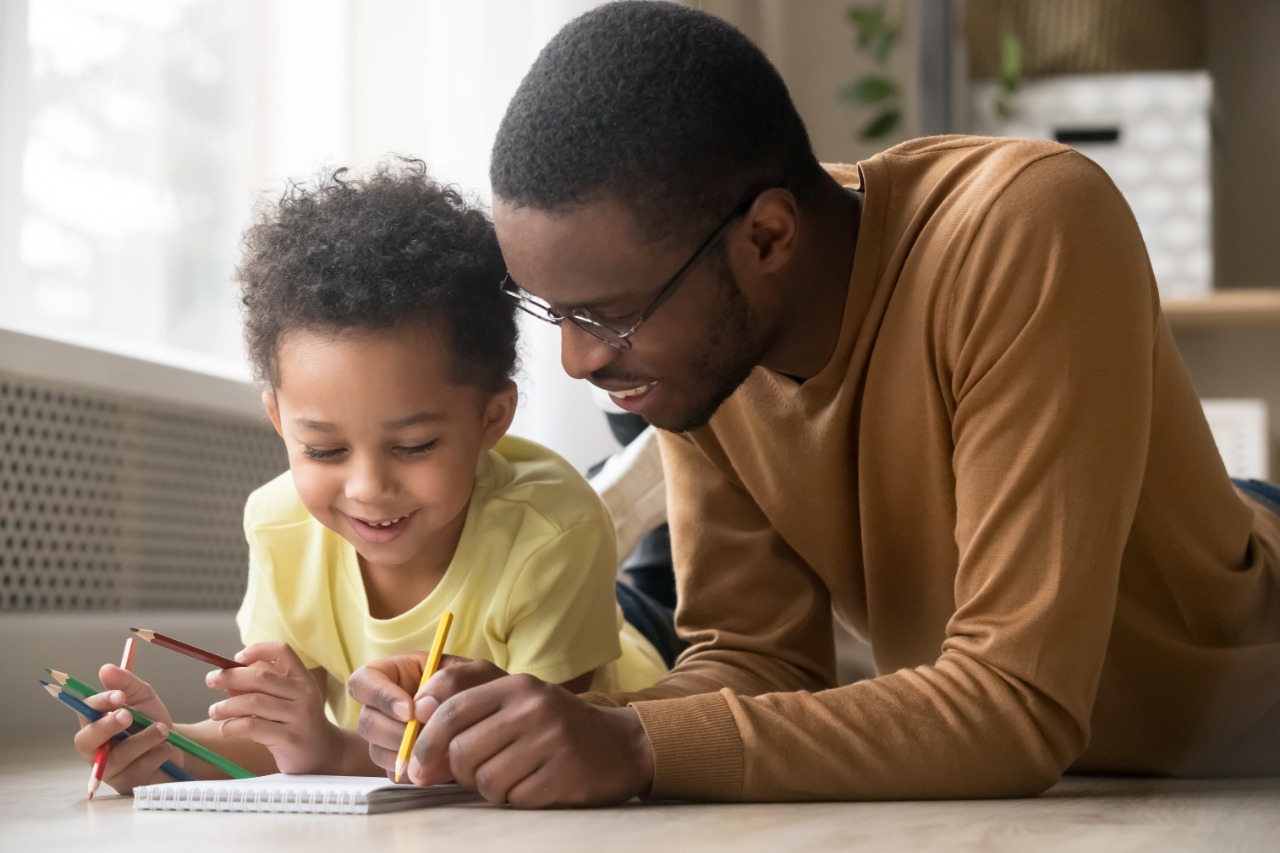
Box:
[133,774,480,815]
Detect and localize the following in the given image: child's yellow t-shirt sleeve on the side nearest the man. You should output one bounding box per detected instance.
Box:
[503,506,622,684]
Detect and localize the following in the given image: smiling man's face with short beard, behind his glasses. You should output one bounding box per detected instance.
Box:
[494,200,767,432]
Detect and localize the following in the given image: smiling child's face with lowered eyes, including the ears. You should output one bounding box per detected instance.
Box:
[264,324,516,573]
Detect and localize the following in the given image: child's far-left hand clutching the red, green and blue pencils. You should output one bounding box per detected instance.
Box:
[74,663,183,794]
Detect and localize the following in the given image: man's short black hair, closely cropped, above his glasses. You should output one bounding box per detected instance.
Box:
[489,1,820,241]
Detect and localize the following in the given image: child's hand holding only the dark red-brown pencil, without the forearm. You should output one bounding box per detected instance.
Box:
[205,643,343,774]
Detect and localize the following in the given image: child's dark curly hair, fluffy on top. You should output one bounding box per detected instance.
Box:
[237,159,517,392]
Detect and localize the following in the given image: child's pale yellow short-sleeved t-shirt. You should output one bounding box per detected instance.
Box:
[236,435,667,729]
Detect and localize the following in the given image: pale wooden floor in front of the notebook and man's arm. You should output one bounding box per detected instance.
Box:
[0,733,1280,853]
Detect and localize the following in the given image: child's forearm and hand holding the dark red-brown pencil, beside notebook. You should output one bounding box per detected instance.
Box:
[204,643,383,776]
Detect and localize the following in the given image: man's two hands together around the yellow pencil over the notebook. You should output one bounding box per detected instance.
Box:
[349,654,653,808]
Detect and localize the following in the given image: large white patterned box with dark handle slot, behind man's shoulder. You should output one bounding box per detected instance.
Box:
[970,70,1213,298]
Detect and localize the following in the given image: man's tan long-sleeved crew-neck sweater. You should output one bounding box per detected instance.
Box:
[588,137,1280,800]
